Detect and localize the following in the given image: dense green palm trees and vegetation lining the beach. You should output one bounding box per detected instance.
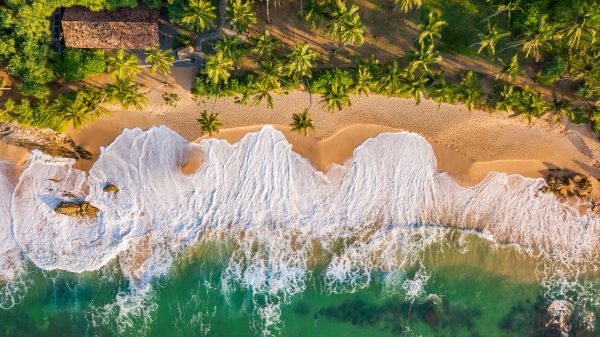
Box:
[0,0,600,133]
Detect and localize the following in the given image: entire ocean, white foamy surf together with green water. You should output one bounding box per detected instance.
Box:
[0,126,600,337]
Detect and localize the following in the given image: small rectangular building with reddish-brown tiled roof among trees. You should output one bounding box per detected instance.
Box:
[61,6,159,50]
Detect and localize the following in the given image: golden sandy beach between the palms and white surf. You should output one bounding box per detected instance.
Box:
[0,68,600,198]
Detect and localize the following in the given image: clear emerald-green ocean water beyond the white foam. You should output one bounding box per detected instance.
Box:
[0,237,600,337]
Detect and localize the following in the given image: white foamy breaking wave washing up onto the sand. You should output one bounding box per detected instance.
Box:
[0,126,600,333]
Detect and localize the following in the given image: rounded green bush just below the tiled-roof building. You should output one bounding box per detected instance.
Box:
[56,48,106,81]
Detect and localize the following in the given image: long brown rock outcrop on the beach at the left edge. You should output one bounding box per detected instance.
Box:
[0,122,93,159]
